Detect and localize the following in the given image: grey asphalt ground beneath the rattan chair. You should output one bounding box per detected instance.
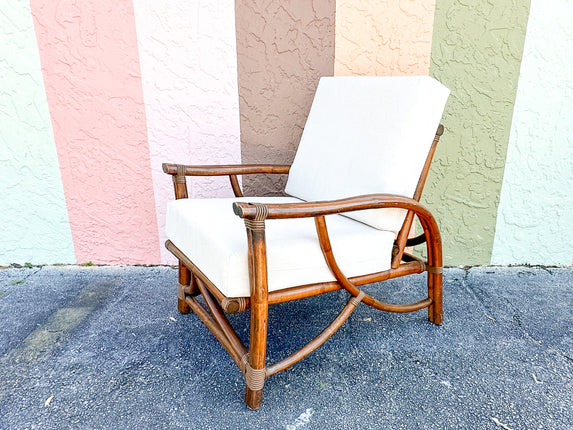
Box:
[0,266,573,430]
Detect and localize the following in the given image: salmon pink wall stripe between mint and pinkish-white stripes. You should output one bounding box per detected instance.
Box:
[30,0,160,264]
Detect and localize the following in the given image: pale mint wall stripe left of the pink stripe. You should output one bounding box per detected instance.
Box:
[0,0,76,265]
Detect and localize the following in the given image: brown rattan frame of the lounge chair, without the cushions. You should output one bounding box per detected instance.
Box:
[163,125,444,409]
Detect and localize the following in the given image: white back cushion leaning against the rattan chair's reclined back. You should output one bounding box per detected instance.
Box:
[285,76,450,232]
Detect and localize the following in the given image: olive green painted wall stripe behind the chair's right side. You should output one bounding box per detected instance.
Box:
[422,0,529,264]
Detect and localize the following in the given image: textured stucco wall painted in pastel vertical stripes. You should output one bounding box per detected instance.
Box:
[0,0,573,265]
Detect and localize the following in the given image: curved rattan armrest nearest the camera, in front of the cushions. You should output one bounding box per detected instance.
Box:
[233,194,433,219]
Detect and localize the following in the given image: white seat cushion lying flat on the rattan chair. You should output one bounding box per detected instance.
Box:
[166,197,395,297]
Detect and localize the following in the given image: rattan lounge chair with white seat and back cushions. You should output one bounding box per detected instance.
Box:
[163,76,449,409]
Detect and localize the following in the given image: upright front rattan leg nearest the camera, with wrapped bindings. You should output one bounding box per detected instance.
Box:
[243,218,268,409]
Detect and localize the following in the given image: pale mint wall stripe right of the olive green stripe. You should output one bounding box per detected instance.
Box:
[492,0,573,265]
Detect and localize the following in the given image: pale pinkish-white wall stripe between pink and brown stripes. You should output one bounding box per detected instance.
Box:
[134,0,241,263]
